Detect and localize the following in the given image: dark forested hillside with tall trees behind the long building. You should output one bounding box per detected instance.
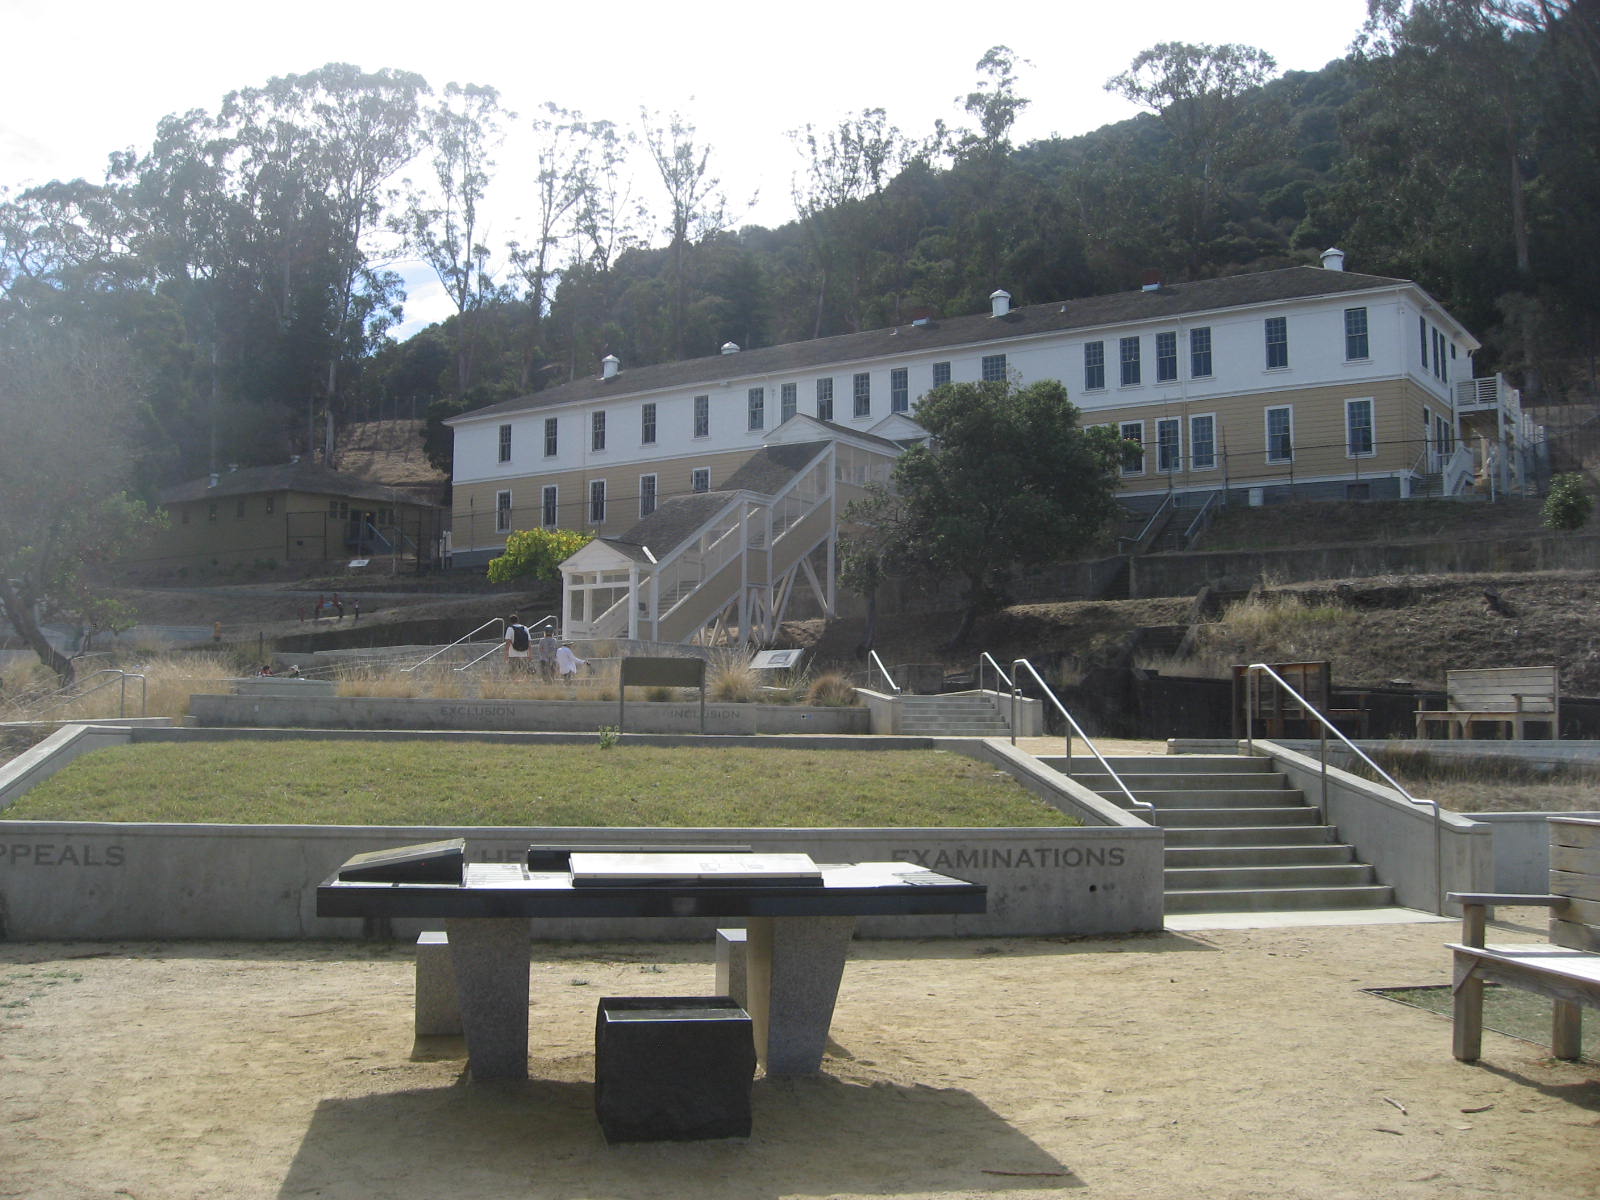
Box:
[0,0,1600,494]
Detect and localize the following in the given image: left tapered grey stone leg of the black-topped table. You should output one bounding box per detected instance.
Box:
[445,917,531,1080]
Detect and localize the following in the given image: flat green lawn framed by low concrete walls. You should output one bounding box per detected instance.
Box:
[3,741,1078,827]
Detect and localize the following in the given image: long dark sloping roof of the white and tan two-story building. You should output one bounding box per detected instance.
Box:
[445,267,1414,426]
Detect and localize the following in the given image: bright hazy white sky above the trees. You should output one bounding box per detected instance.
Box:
[0,0,1366,336]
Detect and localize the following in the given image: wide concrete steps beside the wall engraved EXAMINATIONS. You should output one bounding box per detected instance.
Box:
[1042,754,1394,912]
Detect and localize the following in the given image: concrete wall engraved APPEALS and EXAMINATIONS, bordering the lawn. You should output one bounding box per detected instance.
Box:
[0,723,1163,941]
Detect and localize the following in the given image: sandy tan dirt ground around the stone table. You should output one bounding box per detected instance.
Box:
[0,910,1600,1200]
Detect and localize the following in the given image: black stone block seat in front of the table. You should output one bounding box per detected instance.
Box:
[595,995,755,1142]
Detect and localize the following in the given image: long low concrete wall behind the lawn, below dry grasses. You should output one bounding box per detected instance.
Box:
[189,694,870,734]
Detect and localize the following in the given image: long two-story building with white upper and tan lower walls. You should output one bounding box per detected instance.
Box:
[450,250,1525,643]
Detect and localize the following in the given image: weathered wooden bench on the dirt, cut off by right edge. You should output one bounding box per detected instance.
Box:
[1450,816,1600,1062]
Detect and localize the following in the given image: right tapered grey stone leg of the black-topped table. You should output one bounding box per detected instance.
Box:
[746,917,856,1075]
